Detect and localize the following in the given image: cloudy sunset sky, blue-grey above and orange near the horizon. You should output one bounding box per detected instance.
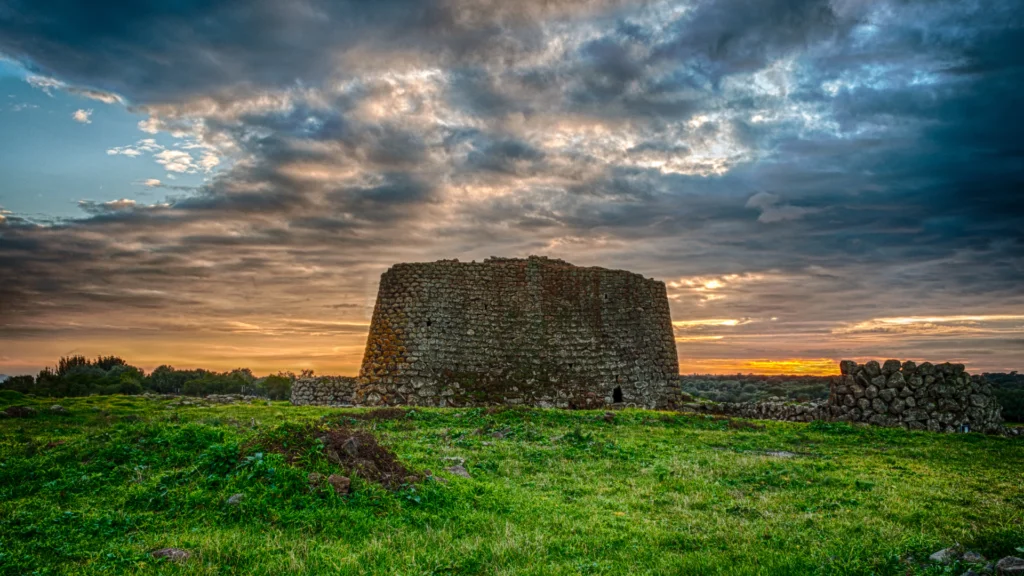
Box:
[0,0,1024,374]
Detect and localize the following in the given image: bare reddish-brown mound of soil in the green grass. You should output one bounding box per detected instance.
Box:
[319,426,419,490]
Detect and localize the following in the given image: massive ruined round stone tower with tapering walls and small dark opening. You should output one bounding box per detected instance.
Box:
[355,256,679,408]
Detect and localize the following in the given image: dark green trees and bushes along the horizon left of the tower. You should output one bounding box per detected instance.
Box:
[0,356,292,400]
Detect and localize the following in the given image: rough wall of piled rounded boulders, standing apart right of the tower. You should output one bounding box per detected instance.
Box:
[828,360,1002,431]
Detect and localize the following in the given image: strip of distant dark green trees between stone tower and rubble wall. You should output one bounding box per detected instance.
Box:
[682,374,828,402]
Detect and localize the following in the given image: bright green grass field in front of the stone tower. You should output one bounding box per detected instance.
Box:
[0,397,1024,575]
